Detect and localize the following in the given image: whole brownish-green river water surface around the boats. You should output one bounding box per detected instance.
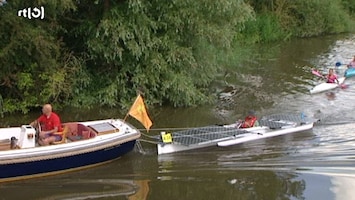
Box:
[0,35,355,200]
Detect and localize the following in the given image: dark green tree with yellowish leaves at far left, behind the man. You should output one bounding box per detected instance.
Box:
[0,0,78,112]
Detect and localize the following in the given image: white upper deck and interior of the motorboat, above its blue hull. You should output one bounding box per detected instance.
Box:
[0,119,140,159]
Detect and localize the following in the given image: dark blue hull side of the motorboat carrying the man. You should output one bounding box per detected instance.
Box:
[0,140,136,181]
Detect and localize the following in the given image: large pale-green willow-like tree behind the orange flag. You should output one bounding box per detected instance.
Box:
[68,0,252,106]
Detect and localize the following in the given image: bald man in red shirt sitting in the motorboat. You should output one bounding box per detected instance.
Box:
[31,104,63,145]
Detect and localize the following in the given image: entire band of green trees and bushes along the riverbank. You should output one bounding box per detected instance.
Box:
[0,0,355,117]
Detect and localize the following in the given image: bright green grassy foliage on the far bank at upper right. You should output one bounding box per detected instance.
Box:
[241,0,355,43]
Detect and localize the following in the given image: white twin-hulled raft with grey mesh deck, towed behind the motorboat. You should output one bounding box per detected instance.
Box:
[157,115,314,155]
